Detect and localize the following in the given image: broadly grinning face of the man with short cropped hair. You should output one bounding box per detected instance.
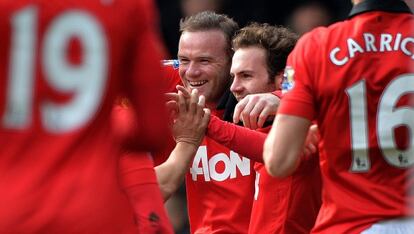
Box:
[178,30,231,105]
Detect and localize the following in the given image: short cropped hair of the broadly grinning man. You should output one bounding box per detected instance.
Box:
[180,11,239,56]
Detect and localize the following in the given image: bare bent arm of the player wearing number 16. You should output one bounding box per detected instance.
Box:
[263,114,311,177]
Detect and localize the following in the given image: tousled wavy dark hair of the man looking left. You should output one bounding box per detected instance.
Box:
[232,23,298,82]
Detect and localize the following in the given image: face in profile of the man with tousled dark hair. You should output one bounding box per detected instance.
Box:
[230,47,276,101]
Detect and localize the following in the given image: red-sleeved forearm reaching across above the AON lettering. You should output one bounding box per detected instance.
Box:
[206,116,267,162]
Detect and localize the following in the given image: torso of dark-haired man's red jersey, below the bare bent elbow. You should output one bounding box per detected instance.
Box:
[247,127,322,234]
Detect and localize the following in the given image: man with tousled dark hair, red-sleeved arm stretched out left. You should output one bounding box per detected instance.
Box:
[202,23,321,234]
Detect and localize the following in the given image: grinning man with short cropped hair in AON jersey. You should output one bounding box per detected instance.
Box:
[156,12,255,233]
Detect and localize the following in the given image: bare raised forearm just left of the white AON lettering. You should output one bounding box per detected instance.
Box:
[155,142,198,201]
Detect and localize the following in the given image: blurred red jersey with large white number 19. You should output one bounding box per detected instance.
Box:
[0,0,167,233]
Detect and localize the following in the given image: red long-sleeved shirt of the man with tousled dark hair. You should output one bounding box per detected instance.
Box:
[207,116,322,234]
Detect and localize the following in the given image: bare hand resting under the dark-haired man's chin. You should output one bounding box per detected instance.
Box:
[233,93,280,130]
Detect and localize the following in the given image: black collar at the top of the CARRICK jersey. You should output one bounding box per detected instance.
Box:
[348,0,412,18]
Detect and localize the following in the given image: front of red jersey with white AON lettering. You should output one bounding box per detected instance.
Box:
[186,111,255,233]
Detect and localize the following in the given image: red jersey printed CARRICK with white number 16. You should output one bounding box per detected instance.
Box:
[279,1,414,233]
